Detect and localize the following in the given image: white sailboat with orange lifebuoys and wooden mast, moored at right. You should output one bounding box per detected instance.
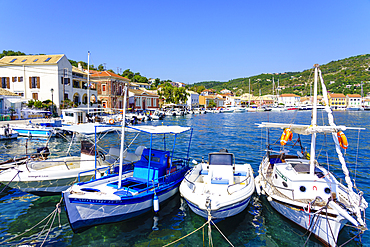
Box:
[255,65,368,246]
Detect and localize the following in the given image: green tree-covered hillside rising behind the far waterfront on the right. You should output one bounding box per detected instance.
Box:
[189,54,370,96]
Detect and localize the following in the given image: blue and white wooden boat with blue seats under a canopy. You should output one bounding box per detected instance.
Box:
[63,126,192,232]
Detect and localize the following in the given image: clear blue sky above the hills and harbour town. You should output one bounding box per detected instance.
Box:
[0,0,370,83]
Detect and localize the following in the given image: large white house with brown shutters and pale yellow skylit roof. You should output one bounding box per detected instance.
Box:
[0,54,97,113]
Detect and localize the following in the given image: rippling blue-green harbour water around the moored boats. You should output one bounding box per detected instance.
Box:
[0,111,370,246]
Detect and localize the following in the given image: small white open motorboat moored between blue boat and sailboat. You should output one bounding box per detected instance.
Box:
[180,149,255,219]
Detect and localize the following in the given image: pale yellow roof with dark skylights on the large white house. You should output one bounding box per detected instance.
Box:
[0,54,65,66]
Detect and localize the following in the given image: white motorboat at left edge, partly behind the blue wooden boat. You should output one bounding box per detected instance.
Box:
[0,141,109,195]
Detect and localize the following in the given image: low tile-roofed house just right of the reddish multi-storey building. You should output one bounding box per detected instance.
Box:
[128,89,159,111]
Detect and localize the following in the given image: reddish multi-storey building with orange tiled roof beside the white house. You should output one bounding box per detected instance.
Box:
[90,71,130,109]
